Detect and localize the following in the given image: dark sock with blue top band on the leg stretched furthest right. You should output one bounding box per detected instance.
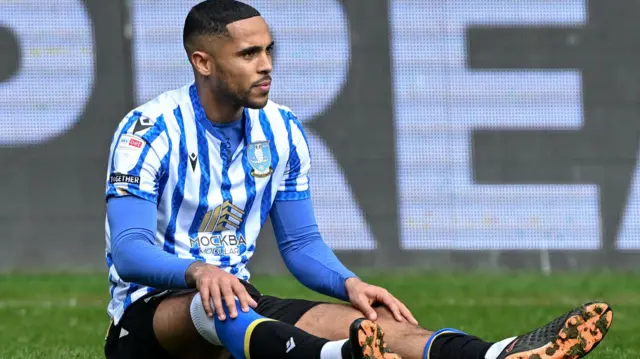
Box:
[424,329,492,359]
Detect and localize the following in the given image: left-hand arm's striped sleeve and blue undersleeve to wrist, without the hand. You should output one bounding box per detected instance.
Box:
[106,112,194,288]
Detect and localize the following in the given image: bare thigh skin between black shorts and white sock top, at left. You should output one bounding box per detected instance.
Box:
[153,291,229,359]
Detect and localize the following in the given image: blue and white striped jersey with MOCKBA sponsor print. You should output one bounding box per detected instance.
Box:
[106,84,310,323]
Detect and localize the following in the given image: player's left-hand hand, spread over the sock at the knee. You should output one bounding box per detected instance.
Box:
[186,262,258,320]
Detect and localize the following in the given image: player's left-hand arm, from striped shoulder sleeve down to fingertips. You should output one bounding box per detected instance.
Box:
[107,113,257,320]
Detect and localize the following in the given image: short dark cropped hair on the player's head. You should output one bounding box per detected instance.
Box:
[182,0,260,51]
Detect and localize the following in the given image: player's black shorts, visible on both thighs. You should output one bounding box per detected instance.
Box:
[104,281,322,359]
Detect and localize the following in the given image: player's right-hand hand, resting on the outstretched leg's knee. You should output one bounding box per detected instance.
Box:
[345,277,418,325]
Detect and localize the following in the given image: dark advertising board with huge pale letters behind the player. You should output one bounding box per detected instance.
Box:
[0,0,640,272]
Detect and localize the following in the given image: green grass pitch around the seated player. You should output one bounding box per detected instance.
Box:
[0,273,640,359]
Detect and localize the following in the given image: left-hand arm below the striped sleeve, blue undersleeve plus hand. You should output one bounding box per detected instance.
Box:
[107,196,257,320]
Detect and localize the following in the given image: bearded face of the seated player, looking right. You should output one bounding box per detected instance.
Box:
[211,16,273,108]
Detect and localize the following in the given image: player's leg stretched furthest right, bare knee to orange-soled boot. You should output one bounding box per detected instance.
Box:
[296,303,613,359]
